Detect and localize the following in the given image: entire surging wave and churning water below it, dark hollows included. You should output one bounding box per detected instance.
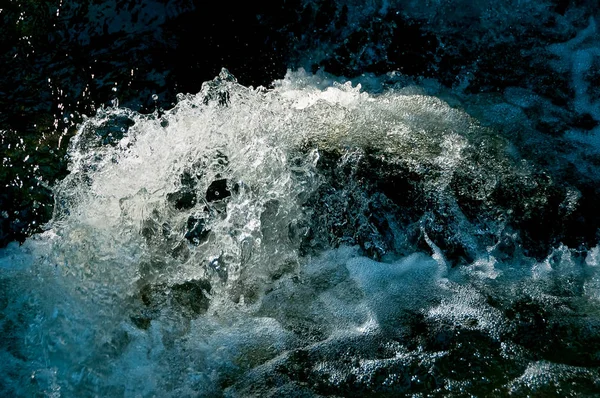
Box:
[0,70,600,397]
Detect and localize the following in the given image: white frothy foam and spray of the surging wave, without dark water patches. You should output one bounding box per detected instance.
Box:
[0,72,600,397]
